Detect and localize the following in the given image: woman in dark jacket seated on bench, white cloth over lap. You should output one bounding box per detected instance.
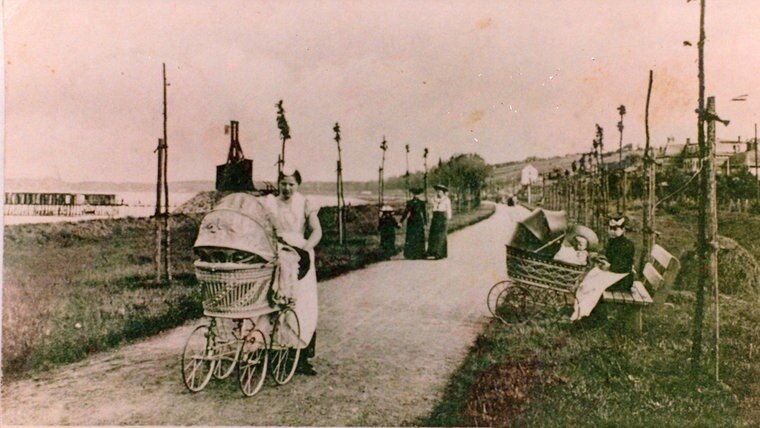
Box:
[570,216,635,321]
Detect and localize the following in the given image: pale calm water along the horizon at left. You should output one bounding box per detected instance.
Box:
[3,192,367,225]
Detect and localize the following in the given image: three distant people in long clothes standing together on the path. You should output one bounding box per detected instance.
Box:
[378,184,452,260]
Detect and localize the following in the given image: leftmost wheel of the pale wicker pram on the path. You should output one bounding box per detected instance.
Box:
[182,325,215,392]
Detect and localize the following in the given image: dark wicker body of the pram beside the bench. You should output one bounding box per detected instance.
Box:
[506,245,588,293]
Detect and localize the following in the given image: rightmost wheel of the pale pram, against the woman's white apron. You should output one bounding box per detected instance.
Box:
[270,308,301,385]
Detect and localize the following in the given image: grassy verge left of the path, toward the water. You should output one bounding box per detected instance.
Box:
[2,201,493,379]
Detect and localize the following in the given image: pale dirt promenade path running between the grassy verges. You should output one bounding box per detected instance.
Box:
[0,205,527,426]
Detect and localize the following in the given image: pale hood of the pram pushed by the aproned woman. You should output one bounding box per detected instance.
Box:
[193,193,277,261]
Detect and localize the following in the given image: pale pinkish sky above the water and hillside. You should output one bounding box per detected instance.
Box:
[3,0,760,182]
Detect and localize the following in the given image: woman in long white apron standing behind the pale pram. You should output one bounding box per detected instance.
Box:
[267,170,322,376]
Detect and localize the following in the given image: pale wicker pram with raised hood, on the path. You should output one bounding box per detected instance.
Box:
[182,193,300,396]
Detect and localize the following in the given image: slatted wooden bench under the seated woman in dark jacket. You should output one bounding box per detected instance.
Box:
[602,244,681,333]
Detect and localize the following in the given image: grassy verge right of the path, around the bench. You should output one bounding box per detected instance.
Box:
[416,209,760,427]
